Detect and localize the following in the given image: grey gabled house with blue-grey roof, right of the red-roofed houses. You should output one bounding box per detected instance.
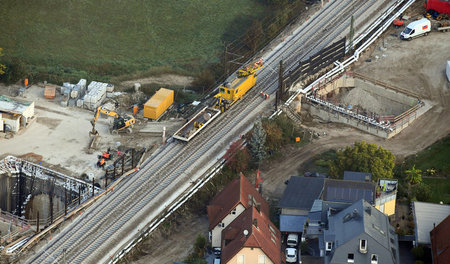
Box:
[324,200,399,264]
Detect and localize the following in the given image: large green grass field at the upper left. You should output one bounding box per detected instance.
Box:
[0,0,268,81]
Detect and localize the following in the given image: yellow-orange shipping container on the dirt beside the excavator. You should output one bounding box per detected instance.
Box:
[144,88,174,120]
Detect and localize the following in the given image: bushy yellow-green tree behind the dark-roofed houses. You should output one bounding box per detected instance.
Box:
[330,141,395,182]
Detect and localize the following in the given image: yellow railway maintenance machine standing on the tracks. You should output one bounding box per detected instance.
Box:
[214,59,263,112]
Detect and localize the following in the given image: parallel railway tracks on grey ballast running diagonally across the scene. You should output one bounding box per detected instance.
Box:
[27,0,402,263]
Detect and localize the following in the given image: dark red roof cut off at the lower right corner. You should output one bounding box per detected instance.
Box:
[430,215,450,264]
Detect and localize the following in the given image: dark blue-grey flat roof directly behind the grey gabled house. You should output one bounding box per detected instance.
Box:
[323,179,376,204]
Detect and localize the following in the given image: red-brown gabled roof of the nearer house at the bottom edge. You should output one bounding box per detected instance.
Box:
[221,206,281,264]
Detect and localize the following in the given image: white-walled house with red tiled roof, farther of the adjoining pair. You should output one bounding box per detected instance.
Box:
[207,174,269,248]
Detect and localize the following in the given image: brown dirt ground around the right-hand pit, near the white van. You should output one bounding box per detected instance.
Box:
[262,24,450,198]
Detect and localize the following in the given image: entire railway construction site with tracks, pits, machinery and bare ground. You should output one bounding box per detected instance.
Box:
[0,1,450,263]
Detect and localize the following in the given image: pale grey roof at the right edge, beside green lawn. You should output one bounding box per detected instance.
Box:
[413,202,450,245]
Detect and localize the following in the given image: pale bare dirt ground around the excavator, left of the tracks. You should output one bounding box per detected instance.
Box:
[0,85,166,177]
